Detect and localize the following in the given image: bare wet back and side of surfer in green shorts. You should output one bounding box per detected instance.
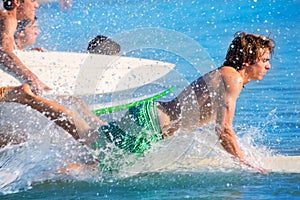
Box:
[158,69,225,135]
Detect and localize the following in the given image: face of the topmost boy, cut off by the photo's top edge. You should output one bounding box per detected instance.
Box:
[17,0,39,21]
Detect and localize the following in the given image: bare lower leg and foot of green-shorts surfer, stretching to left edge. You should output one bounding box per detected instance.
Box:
[0,84,90,139]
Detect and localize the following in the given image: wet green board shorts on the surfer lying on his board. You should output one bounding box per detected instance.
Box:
[92,101,162,155]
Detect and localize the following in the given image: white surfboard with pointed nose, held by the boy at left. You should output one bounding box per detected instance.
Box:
[0,51,175,95]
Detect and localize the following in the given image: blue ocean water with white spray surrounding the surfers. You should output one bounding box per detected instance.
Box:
[0,0,300,199]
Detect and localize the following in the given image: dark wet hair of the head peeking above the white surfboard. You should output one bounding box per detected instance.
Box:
[87,35,121,55]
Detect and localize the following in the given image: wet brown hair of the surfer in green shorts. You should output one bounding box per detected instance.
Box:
[223,32,275,70]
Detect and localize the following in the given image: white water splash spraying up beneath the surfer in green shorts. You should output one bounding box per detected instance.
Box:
[0,103,294,194]
